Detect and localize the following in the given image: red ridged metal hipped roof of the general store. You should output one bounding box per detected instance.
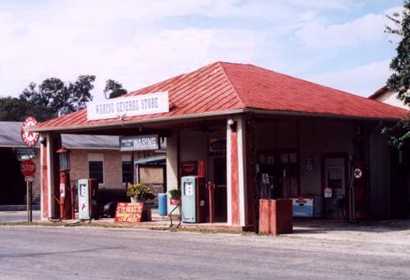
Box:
[38,62,408,131]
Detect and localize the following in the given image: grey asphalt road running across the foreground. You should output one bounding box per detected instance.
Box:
[0,226,410,280]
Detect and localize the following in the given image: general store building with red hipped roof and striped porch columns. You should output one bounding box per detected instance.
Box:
[36,62,409,228]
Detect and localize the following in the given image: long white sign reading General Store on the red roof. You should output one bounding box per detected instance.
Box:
[87,92,169,120]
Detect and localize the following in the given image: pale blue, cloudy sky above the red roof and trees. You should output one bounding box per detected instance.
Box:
[0,0,403,100]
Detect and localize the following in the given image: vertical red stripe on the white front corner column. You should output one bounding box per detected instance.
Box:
[231,131,240,225]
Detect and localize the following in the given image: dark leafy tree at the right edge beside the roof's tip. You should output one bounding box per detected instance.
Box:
[383,0,410,150]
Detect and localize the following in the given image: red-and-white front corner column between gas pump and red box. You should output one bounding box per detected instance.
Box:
[226,117,247,227]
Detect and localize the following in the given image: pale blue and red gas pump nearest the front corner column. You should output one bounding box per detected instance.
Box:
[181,176,209,223]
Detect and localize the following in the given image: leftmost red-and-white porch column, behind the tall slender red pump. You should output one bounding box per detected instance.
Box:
[40,133,61,220]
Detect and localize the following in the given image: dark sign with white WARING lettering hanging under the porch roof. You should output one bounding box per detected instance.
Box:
[120,134,159,152]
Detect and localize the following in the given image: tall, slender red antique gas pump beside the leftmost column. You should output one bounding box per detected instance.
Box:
[57,148,74,220]
